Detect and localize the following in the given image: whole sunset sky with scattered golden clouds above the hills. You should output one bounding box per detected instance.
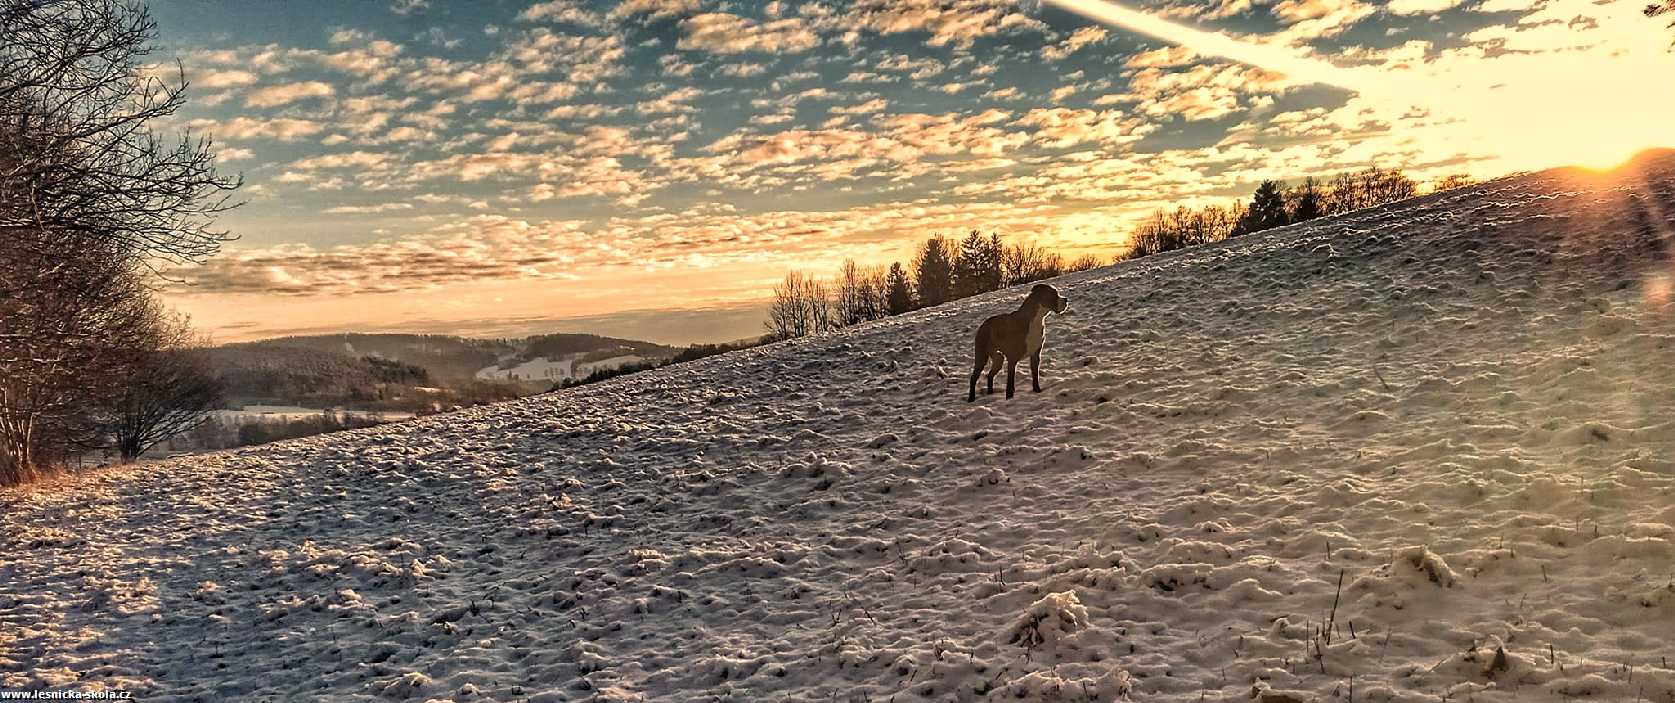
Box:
[151,0,1675,343]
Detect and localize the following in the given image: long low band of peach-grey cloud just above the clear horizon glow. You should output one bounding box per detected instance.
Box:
[174,201,1139,305]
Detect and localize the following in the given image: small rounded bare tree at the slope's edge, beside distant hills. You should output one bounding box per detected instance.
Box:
[111,318,221,462]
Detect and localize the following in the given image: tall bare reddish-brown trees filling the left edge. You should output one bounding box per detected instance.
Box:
[0,0,240,482]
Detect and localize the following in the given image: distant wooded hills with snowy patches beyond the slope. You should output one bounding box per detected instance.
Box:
[211,333,680,410]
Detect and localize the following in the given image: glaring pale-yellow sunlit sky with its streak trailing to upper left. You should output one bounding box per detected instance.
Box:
[1045,0,1675,171]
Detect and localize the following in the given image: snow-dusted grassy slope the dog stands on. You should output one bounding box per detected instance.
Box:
[0,154,1675,701]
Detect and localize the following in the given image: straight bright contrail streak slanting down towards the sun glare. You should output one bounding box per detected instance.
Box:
[1042,0,1367,90]
